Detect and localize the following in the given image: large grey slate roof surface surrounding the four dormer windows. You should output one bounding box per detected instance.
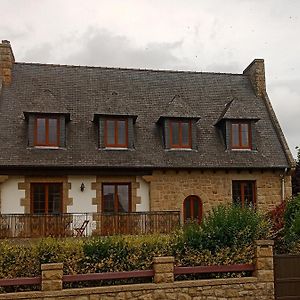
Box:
[0,63,290,170]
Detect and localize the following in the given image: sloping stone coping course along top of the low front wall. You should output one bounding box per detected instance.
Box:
[0,277,259,300]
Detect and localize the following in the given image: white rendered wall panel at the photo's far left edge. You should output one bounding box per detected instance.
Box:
[0,176,25,214]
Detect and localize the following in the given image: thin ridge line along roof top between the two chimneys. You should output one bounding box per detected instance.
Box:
[14,62,246,77]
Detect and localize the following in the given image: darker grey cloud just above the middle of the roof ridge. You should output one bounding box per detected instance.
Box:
[63,28,182,69]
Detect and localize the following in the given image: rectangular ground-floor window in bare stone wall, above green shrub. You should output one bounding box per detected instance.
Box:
[232,180,256,207]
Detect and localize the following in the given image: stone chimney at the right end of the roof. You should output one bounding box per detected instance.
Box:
[243,59,266,97]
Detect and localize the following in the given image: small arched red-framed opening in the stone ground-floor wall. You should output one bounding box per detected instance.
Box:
[183,195,202,223]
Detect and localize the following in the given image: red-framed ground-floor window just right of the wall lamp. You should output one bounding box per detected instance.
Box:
[102,183,131,213]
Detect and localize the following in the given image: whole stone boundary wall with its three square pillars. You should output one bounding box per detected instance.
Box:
[0,241,274,300]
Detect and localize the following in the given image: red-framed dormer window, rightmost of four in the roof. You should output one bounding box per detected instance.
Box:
[231,123,251,149]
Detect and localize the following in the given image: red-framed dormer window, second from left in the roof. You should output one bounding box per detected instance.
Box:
[104,119,128,148]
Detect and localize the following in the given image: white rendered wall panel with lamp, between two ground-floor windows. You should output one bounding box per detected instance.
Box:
[67,175,97,213]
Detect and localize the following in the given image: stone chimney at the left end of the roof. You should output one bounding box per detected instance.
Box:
[0,40,15,86]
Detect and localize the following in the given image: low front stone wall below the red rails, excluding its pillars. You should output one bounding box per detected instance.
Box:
[0,277,274,300]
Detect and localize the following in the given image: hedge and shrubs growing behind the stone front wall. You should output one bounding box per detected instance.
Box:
[0,196,300,292]
